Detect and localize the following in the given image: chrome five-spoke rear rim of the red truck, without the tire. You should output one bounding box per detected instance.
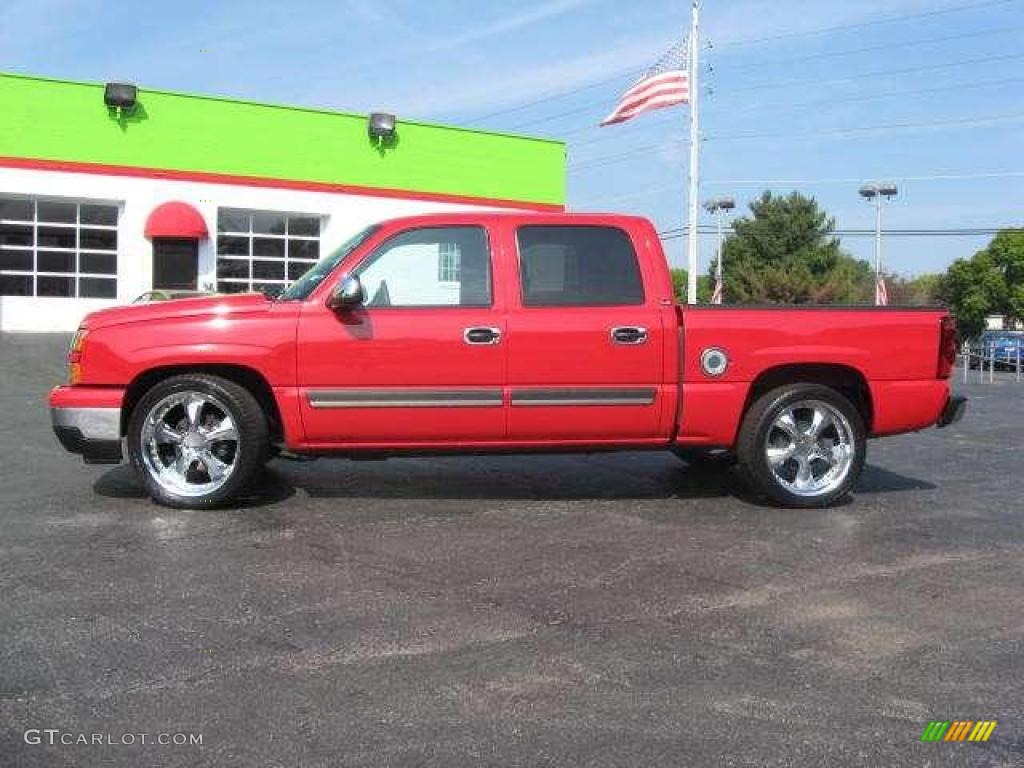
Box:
[764,400,856,497]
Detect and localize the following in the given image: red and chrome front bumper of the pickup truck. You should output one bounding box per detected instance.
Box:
[50,387,124,464]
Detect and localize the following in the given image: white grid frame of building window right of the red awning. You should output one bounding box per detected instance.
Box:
[214,206,327,293]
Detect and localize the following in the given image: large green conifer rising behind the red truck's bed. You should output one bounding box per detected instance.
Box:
[723,191,873,304]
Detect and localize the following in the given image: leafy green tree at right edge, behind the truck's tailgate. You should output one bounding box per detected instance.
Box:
[938,229,1024,338]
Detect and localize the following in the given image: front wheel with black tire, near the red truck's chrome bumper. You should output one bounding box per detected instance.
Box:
[127,374,269,509]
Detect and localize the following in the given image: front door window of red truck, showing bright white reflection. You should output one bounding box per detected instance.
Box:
[355,226,490,307]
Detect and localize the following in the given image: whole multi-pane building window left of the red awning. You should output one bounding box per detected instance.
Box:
[0,196,118,299]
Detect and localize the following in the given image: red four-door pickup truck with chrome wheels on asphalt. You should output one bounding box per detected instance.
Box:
[49,213,965,508]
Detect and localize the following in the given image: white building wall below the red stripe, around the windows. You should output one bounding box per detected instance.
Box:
[0,168,495,332]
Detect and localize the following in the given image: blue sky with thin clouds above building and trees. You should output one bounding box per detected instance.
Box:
[0,0,1024,274]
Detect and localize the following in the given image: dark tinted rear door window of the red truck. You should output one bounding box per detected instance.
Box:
[517,226,643,306]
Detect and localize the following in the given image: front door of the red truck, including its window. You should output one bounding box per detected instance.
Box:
[298,225,507,444]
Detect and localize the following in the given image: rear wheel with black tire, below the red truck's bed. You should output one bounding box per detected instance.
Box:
[736,384,867,508]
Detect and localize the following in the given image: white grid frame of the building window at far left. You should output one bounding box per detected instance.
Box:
[0,194,122,301]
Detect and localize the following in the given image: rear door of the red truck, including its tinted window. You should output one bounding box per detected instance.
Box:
[507,223,663,442]
